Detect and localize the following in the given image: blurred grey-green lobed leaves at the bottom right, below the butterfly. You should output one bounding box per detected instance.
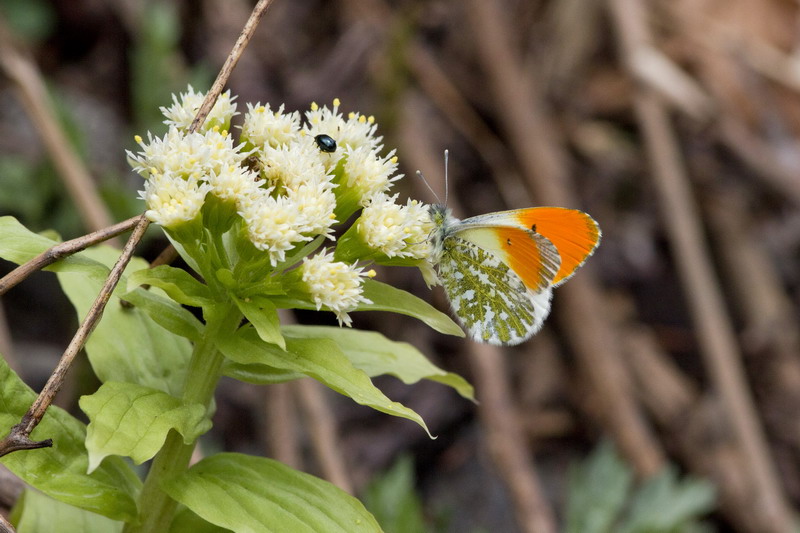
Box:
[565,442,716,533]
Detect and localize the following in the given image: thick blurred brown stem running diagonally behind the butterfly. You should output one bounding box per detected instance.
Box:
[467,0,664,475]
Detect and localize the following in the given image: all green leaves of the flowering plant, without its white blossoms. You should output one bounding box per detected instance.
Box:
[0,210,473,533]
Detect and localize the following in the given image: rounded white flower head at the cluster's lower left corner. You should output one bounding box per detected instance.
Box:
[139,173,211,228]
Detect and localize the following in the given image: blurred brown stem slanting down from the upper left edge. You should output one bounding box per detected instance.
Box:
[0,18,112,239]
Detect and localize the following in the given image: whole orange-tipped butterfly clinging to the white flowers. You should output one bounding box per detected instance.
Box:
[430,204,601,346]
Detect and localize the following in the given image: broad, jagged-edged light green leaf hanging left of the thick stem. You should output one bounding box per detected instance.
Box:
[80,381,211,472]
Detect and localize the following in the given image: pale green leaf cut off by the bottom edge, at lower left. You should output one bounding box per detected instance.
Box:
[11,488,124,533]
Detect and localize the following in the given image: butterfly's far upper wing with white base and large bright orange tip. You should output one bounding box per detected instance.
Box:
[462,207,601,287]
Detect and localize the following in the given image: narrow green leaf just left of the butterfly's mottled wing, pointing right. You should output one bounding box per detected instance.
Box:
[358,279,464,337]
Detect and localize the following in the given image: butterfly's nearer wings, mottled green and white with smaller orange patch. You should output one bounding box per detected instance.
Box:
[438,226,560,345]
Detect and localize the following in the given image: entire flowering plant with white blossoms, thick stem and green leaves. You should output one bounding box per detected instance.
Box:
[0,87,473,533]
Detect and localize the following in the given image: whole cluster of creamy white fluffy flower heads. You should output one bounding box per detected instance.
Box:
[128,87,432,325]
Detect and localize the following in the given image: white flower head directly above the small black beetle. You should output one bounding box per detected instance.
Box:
[305,98,383,152]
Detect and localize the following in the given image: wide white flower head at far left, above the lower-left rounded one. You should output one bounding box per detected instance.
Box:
[128,126,248,180]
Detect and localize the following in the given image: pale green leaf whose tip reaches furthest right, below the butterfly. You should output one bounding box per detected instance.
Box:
[283,325,475,400]
